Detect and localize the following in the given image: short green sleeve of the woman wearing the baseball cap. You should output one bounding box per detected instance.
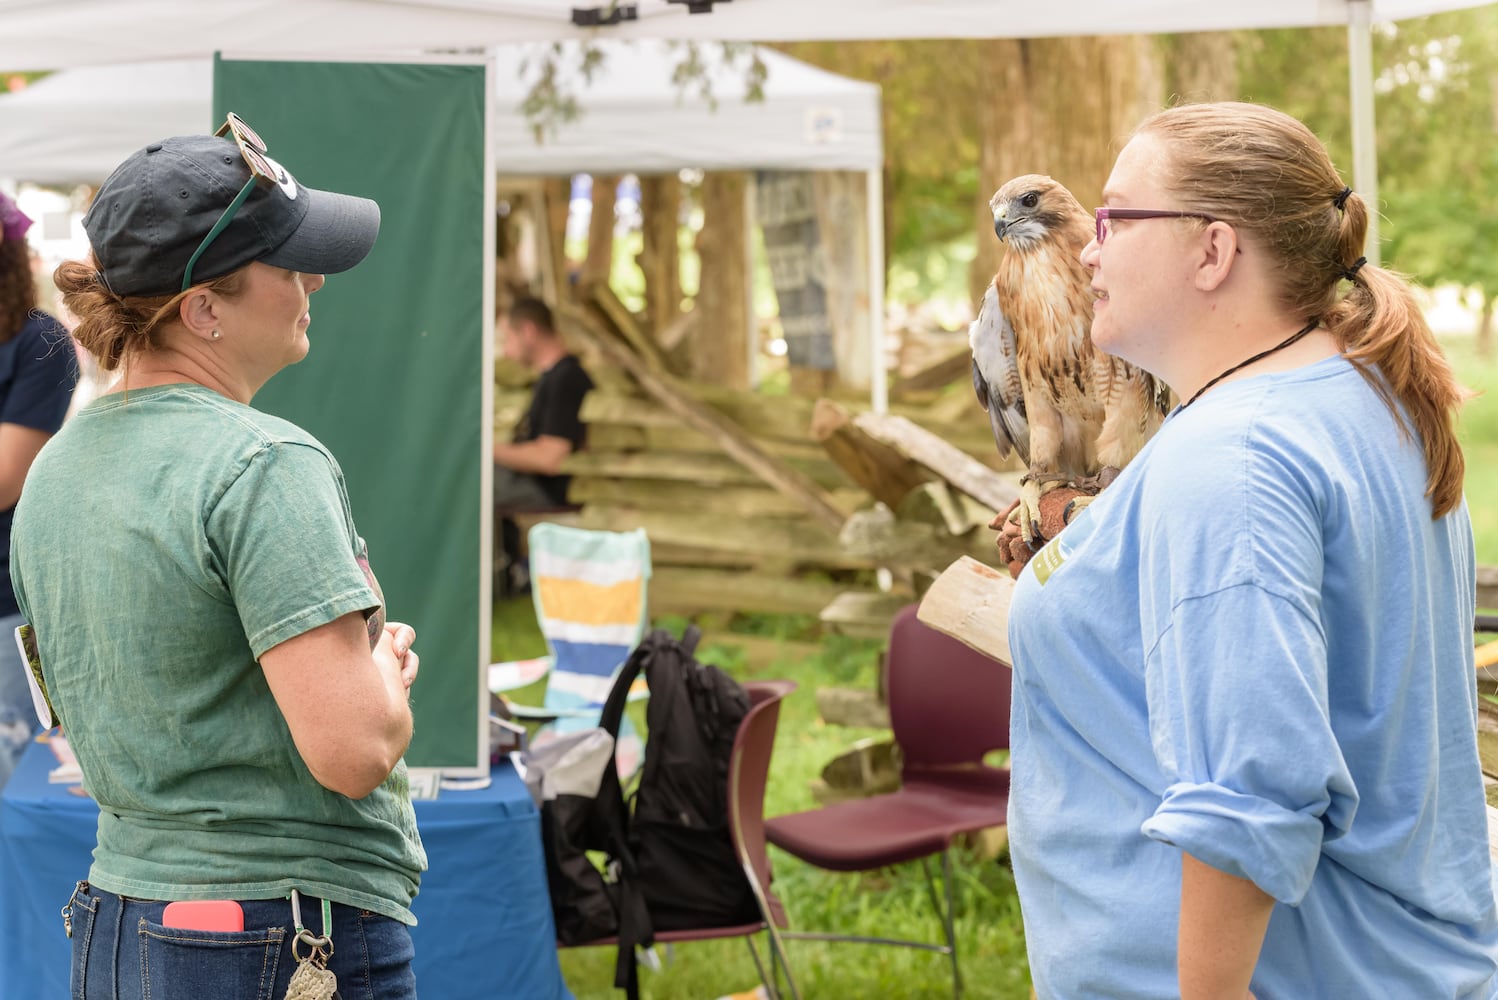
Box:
[208,442,380,659]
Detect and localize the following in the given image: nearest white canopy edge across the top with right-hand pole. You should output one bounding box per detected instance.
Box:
[0,0,1491,254]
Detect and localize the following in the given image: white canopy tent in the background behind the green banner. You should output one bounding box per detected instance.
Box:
[0,40,887,398]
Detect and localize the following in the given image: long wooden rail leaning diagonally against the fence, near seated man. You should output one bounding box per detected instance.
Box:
[563,305,845,533]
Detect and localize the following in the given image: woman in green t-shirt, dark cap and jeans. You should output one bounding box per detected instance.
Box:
[12,115,425,1000]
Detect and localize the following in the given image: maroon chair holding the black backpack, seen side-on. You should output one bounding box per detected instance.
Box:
[566,681,801,1000]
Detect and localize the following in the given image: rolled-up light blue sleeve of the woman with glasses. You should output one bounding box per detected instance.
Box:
[1141,584,1357,904]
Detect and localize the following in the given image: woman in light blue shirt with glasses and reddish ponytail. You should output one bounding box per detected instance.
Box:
[1010,103,1498,1000]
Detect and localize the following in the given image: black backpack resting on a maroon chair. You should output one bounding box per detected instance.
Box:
[541,626,761,999]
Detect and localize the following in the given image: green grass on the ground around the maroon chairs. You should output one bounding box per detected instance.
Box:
[493,600,1029,1000]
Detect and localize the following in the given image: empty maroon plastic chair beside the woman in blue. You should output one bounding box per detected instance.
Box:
[765,605,1010,996]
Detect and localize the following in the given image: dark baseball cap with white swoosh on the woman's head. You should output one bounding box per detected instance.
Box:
[84,135,379,295]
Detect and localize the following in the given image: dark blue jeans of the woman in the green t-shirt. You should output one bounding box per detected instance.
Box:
[64,882,416,1000]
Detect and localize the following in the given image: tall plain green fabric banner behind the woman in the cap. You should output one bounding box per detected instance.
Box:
[213,58,493,774]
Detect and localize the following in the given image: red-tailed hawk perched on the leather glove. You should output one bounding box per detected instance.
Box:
[968,174,1167,542]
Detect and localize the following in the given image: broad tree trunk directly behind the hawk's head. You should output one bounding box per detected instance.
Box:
[969,34,1162,302]
